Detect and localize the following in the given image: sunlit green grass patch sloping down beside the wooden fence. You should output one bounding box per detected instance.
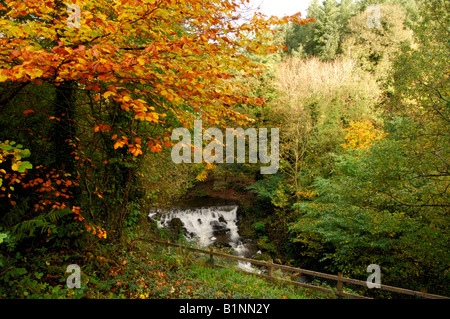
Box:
[118,242,328,299]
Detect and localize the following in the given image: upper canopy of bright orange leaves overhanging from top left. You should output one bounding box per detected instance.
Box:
[0,0,312,140]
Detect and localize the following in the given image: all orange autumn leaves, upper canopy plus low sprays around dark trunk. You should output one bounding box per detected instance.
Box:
[0,0,316,231]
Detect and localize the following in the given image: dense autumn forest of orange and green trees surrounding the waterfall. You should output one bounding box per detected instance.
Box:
[0,0,450,298]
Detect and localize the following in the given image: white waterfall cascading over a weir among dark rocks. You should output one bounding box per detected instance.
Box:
[149,205,255,271]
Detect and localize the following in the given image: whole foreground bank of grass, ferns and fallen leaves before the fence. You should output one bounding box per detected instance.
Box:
[0,220,330,299]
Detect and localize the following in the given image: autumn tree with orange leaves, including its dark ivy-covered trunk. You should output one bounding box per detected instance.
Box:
[0,0,307,237]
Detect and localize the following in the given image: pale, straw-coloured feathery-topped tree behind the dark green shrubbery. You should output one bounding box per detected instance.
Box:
[268,57,381,200]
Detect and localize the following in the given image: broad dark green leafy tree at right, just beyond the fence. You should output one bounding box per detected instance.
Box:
[290,115,450,294]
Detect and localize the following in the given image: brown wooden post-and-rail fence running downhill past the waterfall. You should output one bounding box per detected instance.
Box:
[147,239,450,299]
